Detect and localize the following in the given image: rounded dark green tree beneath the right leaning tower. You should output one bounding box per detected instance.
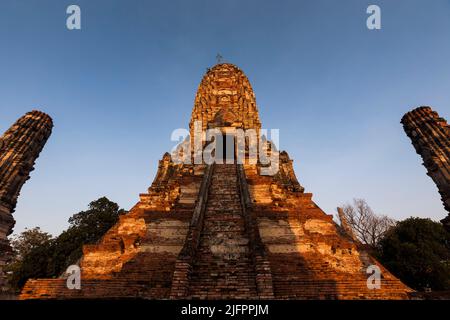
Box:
[378,218,450,291]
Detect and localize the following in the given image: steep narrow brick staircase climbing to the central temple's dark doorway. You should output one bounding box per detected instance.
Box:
[188,164,257,299]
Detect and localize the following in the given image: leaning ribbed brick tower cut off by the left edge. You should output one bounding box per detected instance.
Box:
[0,111,53,292]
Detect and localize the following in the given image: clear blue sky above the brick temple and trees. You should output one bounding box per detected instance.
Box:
[0,0,450,234]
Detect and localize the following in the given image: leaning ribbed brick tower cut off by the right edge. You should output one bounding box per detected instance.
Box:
[401,107,450,230]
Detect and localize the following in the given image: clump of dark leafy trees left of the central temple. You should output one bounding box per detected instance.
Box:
[8,197,126,290]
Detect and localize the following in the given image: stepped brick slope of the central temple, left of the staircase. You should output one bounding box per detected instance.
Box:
[21,154,205,299]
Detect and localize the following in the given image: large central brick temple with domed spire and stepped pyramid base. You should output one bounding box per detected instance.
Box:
[21,64,411,299]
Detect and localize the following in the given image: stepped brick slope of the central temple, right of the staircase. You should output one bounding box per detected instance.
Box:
[246,162,412,299]
